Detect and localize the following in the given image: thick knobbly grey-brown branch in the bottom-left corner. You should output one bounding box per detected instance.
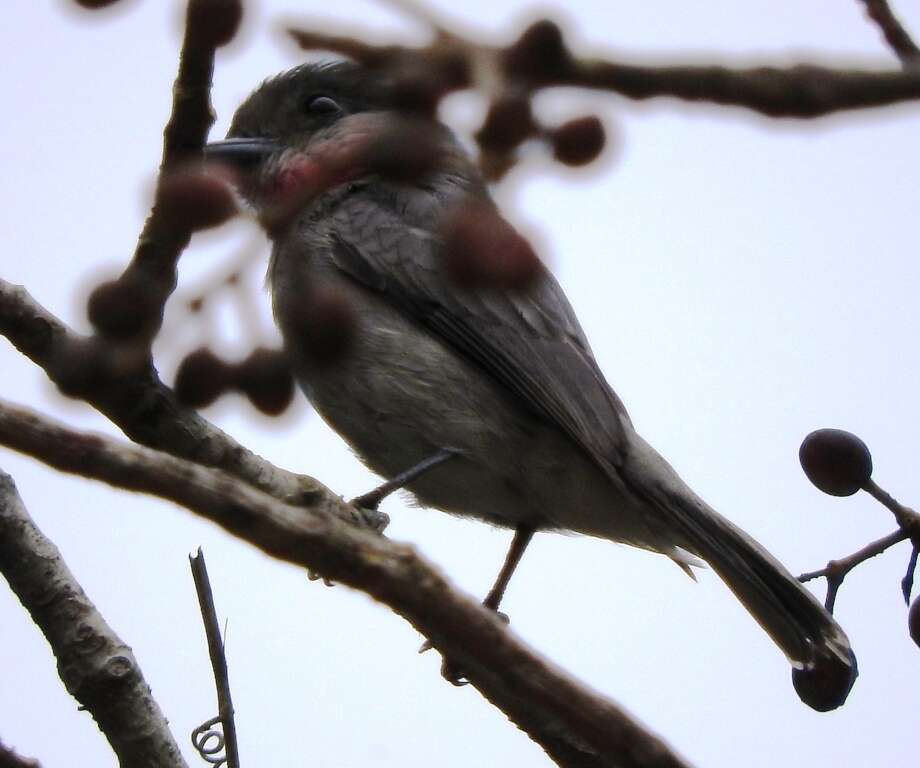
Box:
[0,472,186,768]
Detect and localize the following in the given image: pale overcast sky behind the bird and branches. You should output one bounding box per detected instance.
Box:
[0,0,920,768]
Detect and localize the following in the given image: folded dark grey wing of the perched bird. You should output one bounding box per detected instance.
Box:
[326,185,629,471]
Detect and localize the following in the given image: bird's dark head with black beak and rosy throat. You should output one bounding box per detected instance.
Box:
[205,63,462,219]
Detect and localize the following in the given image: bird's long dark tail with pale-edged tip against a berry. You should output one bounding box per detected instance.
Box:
[656,486,858,711]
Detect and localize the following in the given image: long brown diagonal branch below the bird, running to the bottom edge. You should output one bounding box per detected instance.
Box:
[0,404,686,768]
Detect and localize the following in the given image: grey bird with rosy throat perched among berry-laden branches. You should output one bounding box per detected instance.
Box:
[205,61,858,711]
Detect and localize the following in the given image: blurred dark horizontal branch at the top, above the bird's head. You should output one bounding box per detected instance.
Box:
[288,20,920,118]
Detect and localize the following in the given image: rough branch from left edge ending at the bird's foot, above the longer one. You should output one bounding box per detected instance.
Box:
[0,279,385,527]
